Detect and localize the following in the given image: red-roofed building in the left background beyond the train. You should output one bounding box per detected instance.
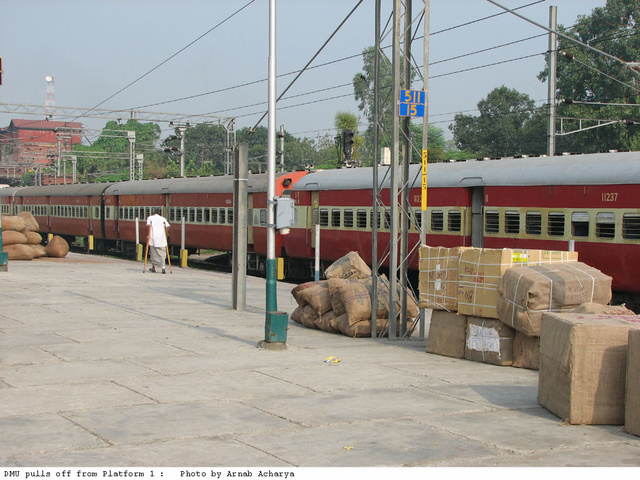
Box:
[0,120,82,182]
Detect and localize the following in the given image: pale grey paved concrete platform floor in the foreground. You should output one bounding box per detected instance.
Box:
[0,253,640,469]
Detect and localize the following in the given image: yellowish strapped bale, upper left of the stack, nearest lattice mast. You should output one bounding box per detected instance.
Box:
[418,246,470,312]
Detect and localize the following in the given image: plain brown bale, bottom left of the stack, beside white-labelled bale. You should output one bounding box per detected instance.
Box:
[427,310,467,358]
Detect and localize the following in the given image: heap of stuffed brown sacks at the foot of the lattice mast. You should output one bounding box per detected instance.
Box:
[291,252,419,337]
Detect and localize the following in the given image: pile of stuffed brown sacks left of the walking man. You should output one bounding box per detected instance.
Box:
[2,212,69,260]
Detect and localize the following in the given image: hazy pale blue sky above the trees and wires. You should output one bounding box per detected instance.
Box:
[0,0,606,139]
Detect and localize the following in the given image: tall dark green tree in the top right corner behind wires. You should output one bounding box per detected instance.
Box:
[538,0,640,153]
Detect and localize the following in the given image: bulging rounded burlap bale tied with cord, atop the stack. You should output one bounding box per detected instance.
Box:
[497,262,612,337]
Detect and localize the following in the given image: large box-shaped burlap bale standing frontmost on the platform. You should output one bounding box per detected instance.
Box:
[538,313,640,425]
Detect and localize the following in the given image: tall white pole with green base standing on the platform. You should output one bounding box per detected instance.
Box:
[258,0,289,348]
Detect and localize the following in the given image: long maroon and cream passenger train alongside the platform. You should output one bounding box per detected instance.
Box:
[0,152,640,305]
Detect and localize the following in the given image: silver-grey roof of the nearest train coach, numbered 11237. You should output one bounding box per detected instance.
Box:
[293,152,640,190]
